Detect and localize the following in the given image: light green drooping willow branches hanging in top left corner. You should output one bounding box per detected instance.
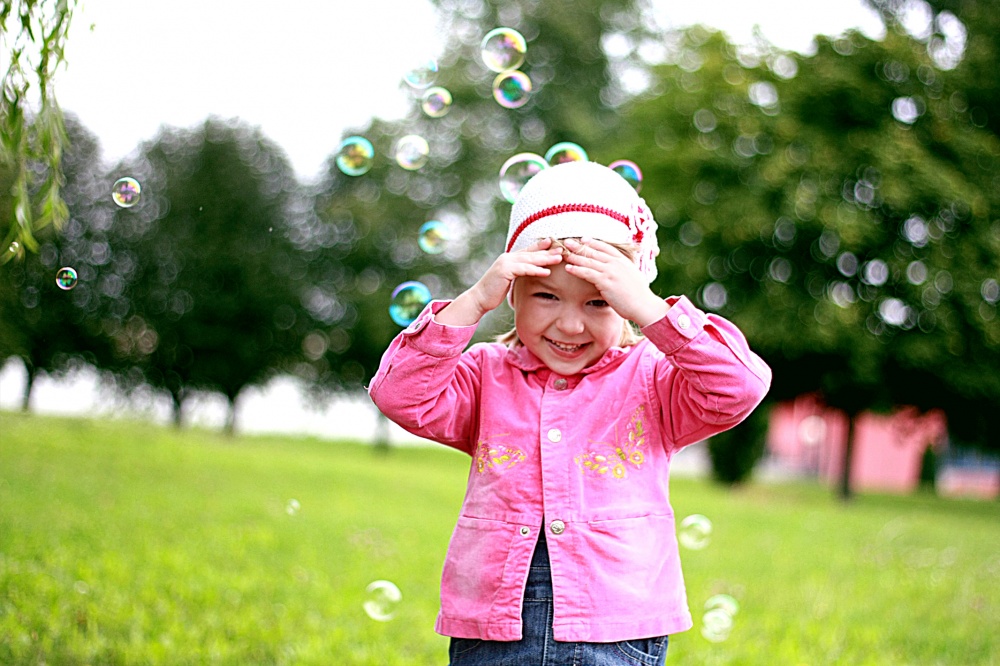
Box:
[0,0,76,256]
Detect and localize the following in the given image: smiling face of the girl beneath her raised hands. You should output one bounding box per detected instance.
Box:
[513,264,625,375]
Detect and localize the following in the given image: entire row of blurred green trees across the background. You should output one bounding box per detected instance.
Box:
[0,0,1000,495]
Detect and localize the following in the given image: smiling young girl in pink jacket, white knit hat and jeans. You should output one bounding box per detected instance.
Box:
[369,162,771,666]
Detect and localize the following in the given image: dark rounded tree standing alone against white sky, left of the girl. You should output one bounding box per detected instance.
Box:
[104,119,309,432]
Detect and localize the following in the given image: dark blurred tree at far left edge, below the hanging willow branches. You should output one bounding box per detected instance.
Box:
[0,111,111,409]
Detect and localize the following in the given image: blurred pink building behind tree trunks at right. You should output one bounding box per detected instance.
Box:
[768,395,1000,497]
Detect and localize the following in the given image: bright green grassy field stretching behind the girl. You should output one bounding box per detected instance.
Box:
[0,412,1000,666]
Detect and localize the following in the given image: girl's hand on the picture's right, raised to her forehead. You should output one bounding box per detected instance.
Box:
[564,238,670,327]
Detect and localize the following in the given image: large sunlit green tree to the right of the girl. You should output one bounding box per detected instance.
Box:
[609,15,1000,496]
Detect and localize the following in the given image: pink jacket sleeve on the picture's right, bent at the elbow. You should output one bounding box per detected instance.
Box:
[642,296,771,449]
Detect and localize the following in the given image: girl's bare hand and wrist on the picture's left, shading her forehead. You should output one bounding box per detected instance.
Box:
[435,238,563,326]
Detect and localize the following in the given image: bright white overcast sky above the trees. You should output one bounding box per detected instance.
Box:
[56,0,881,178]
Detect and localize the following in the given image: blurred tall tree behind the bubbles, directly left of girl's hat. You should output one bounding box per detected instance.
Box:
[300,0,660,418]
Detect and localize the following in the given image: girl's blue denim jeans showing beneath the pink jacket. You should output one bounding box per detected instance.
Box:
[448,534,667,666]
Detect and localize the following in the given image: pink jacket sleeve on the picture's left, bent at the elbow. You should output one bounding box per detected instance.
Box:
[368,301,481,453]
